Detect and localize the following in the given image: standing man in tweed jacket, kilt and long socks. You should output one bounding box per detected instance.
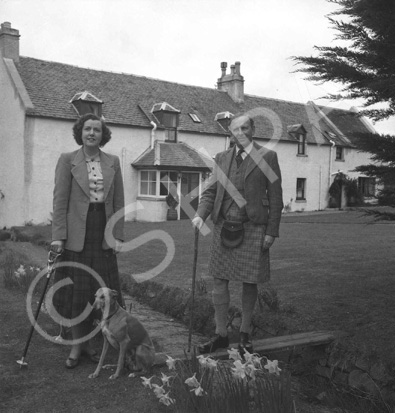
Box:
[192,114,283,354]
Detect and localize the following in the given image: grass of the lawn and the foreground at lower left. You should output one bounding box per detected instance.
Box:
[0,211,395,412]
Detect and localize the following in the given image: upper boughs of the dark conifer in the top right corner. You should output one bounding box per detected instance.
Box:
[293,0,395,121]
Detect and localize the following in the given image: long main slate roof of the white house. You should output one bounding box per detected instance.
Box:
[15,57,374,146]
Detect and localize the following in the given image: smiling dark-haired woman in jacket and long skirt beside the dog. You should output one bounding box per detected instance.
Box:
[51,113,124,369]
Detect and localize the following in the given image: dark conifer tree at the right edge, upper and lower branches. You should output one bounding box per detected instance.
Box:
[293,0,395,205]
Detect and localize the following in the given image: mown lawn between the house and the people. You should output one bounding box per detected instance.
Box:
[115,211,395,362]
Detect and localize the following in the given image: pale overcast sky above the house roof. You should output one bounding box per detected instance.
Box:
[0,0,395,134]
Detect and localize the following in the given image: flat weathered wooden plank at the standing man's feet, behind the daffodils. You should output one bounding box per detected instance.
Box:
[155,331,344,365]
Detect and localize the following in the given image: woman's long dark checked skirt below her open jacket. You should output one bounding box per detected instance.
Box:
[53,209,123,325]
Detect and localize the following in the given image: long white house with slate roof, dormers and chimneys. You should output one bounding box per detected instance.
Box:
[0,22,374,227]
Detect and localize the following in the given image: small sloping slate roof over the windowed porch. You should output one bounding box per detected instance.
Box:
[132,140,214,171]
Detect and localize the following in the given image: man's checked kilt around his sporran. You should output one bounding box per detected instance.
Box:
[208,219,270,284]
